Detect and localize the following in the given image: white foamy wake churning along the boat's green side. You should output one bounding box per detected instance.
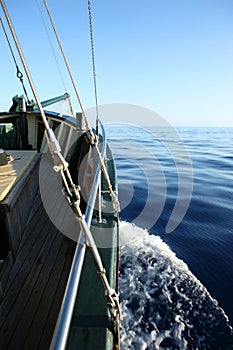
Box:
[119,222,233,350]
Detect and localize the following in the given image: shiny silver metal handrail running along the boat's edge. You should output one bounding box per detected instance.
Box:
[50,124,106,350]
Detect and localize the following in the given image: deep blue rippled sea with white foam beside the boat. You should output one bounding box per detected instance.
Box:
[107,124,233,350]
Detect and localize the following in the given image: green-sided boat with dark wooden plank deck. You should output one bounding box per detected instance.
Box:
[0,112,119,350]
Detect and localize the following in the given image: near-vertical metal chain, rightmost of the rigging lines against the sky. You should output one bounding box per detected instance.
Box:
[88,0,99,135]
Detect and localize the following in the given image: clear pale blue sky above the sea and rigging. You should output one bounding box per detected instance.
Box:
[0,0,233,126]
